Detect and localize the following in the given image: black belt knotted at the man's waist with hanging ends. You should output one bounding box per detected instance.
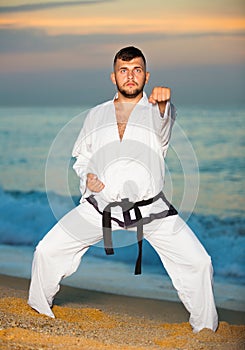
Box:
[86,192,178,275]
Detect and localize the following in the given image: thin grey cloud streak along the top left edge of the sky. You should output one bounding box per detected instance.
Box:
[0,0,112,13]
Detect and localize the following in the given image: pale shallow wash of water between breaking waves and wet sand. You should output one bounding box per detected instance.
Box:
[0,245,245,312]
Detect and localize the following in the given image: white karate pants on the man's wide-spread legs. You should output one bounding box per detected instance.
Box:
[28,201,218,332]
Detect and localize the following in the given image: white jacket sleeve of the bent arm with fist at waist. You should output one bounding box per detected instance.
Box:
[72,116,92,197]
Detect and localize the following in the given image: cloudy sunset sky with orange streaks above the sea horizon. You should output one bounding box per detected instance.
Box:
[0,0,245,107]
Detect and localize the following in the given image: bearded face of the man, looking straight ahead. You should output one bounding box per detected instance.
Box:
[111,57,149,98]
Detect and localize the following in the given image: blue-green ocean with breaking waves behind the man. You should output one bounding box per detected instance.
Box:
[0,106,245,310]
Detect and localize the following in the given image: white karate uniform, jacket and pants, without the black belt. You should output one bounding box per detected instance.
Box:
[28,94,218,332]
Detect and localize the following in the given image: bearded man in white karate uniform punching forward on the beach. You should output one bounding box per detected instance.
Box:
[28,47,218,332]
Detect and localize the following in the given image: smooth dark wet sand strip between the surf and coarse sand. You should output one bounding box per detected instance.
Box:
[0,274,245,325]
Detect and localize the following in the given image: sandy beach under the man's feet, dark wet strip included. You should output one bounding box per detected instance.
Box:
[0,275,245,350]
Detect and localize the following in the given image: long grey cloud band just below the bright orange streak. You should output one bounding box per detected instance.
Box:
[0,27,245,53]
